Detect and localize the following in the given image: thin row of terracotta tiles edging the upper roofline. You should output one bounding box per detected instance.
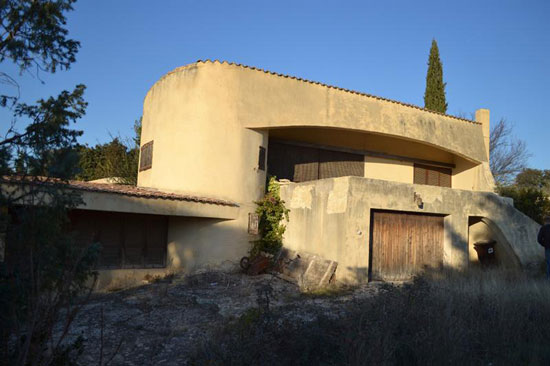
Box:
[161,59,481,125]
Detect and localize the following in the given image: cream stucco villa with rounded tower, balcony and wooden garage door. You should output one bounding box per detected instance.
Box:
[51,61,542,284]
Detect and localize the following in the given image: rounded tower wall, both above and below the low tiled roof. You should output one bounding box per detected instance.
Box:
[138,65,268,271]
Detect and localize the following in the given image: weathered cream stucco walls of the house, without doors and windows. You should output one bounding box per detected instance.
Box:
[69,61,542,281]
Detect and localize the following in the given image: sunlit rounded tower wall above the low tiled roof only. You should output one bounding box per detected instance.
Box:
[138,61,267,202]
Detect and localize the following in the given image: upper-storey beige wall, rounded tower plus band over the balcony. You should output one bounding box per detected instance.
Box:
[138,62,494,203]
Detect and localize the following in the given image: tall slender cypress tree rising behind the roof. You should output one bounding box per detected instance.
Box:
[424,39,447,113]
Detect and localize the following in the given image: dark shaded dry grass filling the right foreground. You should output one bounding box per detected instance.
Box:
[193,270,550,365]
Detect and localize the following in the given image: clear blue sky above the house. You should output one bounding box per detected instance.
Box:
[3,0,550,169]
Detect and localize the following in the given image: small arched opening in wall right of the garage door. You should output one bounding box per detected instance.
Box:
[468,216,520,269]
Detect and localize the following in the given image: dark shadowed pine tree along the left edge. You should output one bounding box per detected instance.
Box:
[0,0,99,366]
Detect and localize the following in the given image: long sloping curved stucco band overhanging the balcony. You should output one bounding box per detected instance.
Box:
[145,60,487,162]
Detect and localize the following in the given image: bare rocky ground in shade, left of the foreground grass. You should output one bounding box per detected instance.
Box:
[69,272,380,365]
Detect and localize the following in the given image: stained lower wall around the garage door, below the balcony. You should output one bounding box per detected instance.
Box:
[281,177,543,282]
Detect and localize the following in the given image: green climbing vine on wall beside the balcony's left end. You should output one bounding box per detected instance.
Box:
[250,177,290,257]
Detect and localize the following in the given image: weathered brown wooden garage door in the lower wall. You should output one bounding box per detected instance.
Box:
[371,211,444,281]
